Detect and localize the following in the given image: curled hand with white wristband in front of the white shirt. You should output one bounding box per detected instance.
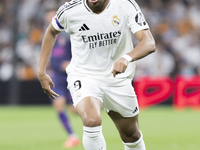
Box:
[112,57,129,78]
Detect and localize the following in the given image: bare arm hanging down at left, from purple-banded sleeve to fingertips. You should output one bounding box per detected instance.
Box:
[37,23,60,99]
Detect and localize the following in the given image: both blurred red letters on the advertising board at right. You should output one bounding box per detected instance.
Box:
[134,76,200,109]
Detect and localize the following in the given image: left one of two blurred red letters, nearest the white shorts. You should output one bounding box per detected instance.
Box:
[134,77,172,108]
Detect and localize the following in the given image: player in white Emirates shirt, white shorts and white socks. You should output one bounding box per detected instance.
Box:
[38,0,155,150]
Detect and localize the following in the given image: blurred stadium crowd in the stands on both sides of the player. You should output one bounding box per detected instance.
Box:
[0,0,200,81]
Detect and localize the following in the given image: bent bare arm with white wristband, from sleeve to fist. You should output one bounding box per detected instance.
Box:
[112,29,156,77]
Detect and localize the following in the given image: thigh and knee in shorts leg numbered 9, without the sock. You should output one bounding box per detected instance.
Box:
[68,76,103,126]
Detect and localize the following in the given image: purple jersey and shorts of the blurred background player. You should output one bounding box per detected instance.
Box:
[50,32,72,103]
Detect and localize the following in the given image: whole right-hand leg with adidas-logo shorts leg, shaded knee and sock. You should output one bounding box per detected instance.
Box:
[104,79,146,150]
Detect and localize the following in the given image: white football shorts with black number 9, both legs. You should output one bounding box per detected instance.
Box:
[67,75,139,117]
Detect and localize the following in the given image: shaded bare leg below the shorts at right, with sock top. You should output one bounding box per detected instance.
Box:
[108,111,146,150]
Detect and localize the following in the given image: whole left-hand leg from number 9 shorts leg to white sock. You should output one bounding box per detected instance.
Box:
[68,74,106,150]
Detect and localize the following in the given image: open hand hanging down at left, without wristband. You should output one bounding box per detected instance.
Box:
[38,73,59,99]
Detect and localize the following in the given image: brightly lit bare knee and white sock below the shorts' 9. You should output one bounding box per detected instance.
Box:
[76,97,106,150]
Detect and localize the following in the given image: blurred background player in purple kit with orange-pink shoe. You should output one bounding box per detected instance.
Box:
[45,5,80,148]
